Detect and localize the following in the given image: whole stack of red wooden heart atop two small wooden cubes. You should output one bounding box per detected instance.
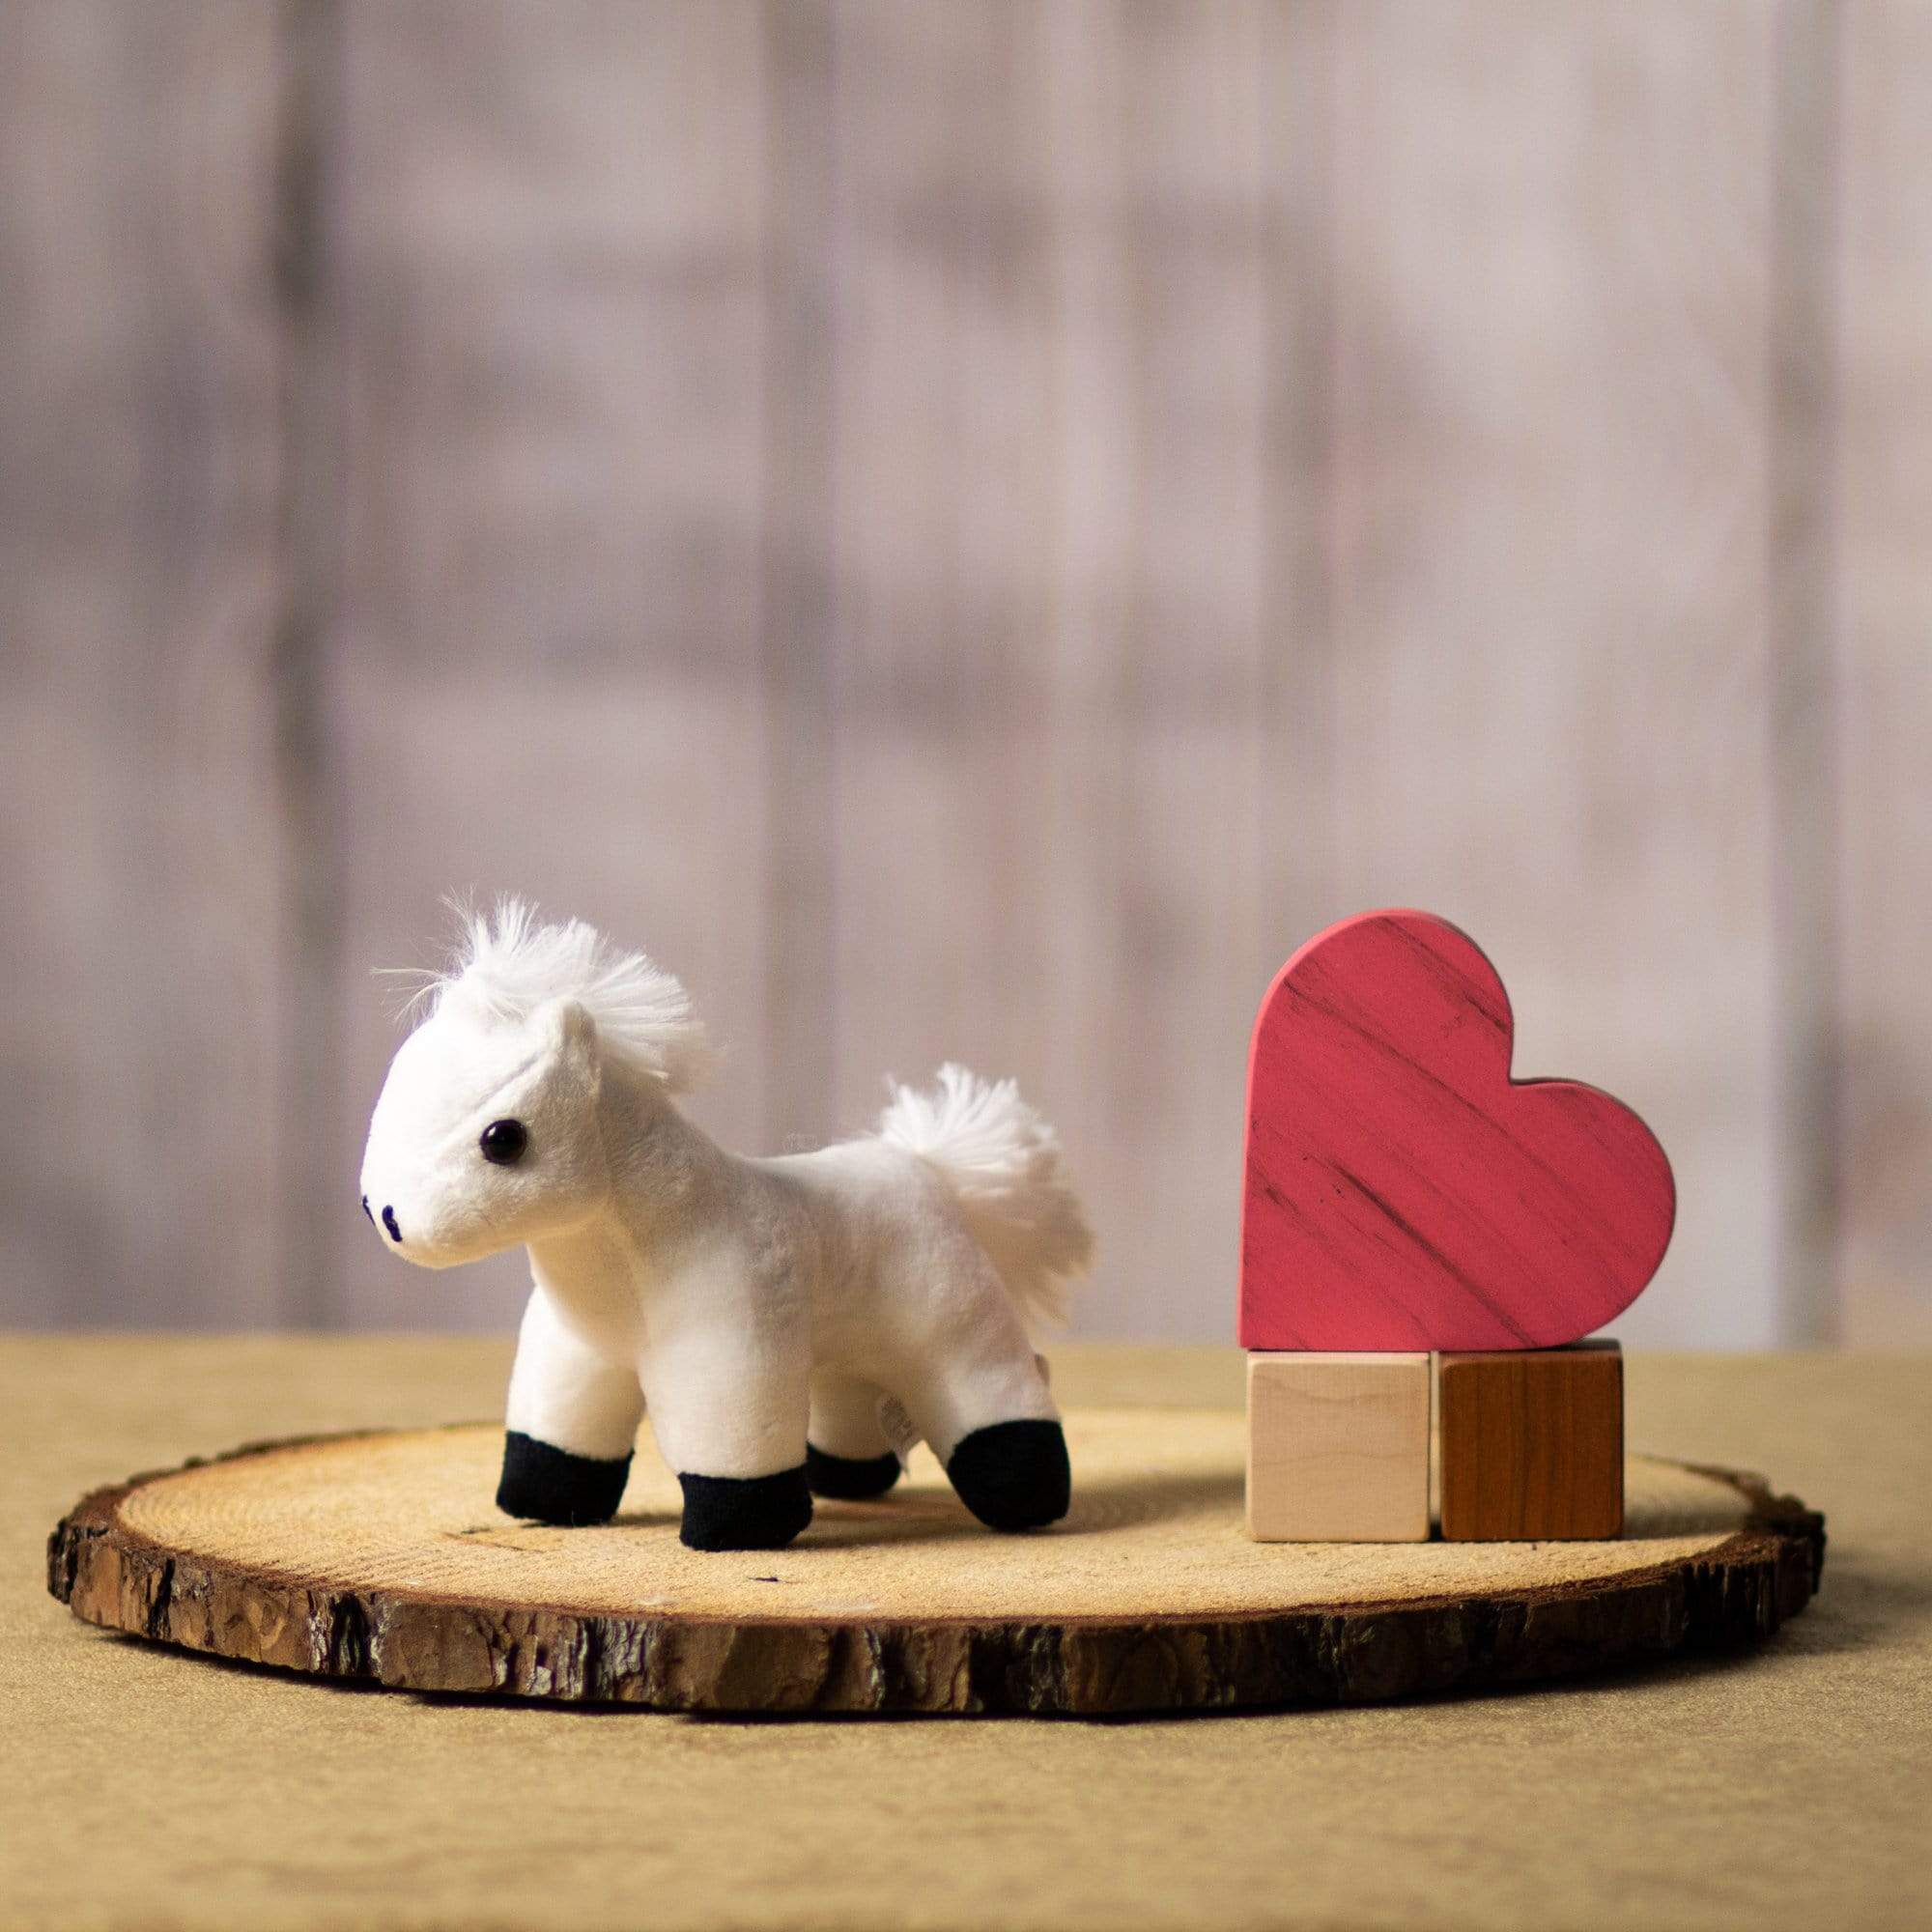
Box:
[1240,912,1677,1542]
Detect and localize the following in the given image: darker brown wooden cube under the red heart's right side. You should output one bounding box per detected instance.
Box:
[1437,1341,1623,1544]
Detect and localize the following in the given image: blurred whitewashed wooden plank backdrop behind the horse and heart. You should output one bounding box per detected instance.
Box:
[0,0,1932,1345]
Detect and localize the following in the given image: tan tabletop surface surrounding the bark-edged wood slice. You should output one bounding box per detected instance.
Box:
[0,1337,1932,1932]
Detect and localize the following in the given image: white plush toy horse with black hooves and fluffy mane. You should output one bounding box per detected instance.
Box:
[361,900,1092,1549]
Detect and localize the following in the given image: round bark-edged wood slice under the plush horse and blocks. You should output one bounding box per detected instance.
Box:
[48,1408,1824,1716]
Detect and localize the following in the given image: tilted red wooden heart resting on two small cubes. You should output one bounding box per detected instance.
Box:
[1240,912,1677,1349]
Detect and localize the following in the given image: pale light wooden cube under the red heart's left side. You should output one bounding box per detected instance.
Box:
[1248,1352,1430,1544]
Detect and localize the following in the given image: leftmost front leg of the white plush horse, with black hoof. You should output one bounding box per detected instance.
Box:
[497,1289,643,1526]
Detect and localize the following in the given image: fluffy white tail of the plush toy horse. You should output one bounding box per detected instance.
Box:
[877,1061,1094,1327]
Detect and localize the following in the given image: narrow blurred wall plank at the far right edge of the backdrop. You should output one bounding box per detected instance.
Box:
[1828,0,1932,1345]
